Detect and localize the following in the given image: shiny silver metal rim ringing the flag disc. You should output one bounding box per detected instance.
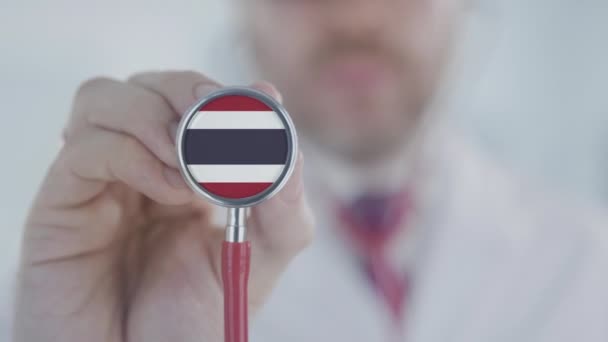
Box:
[175,87,298,208]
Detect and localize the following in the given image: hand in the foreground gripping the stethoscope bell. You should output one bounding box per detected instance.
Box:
[15,72,313,342]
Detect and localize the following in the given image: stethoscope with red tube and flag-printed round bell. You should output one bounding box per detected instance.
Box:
[176,87,297,342]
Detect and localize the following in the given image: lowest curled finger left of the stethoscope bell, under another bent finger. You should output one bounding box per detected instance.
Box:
[40,130,192,206]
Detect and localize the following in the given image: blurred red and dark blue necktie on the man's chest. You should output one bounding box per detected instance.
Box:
[337,192,411,326]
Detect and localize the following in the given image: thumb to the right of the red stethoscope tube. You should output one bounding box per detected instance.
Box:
[247,155,314,300]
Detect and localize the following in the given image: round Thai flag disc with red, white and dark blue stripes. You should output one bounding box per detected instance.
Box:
[183,95,288,198]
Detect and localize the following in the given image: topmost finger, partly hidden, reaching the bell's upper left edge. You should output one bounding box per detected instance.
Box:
[127,71,221,116]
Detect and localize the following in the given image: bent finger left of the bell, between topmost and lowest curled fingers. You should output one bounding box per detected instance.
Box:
[66,78,178,167]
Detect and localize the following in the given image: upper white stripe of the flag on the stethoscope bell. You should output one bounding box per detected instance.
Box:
[188,111,285,129]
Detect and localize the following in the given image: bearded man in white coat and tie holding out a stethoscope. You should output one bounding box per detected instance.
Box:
[14,0,608,342]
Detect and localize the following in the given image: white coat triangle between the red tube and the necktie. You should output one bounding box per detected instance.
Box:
[252,204,385,342]
